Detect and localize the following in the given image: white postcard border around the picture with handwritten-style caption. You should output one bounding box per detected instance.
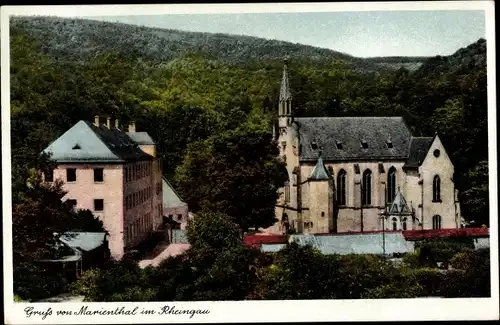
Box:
[0,1,499,324]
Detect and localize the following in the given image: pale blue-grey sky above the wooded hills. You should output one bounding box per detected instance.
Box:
[88,10,486,57]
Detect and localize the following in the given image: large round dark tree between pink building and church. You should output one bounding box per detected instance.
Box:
[175,128,286,231]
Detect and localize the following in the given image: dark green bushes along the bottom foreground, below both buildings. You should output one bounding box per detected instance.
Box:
[73,235,490,301]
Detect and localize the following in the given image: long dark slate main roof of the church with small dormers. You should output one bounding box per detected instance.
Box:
[295,117,411,161]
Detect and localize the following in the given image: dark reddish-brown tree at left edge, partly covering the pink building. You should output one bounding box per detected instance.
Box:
[12,158,104,300]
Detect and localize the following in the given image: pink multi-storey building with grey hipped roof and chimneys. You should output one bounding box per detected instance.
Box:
[44,116,163,260]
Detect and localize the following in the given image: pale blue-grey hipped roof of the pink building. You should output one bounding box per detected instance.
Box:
[43,121,153,163]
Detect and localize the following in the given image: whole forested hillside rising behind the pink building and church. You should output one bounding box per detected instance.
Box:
[10,18,488,222]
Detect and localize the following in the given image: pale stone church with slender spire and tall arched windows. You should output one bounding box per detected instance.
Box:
[272,60,461,234]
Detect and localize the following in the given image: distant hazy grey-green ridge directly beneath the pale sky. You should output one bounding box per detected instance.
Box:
[11,17,426,72]
